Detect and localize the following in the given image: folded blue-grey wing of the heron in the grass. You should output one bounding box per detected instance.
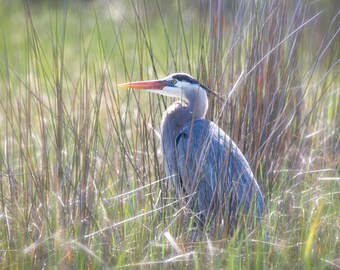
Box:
[176,119,262,220]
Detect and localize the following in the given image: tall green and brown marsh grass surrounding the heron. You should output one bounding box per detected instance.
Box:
[0,1,340,269]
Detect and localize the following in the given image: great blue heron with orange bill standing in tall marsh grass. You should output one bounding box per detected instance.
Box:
[119,73,263,231]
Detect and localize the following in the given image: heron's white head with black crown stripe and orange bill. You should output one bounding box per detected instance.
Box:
[118,73,210,101]
